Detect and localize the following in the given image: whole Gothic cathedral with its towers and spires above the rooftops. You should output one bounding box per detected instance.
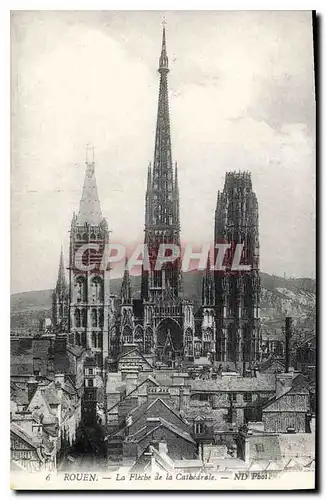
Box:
[53,27,260,370]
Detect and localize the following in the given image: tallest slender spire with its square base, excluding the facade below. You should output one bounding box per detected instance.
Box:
[142,27,181,300]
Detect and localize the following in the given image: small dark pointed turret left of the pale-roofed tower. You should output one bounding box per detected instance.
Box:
[52,248,69,333]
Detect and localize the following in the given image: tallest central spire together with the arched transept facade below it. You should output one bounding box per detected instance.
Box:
[138,27,194,365]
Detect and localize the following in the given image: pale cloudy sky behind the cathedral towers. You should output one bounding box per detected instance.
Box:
[11,11,316,293]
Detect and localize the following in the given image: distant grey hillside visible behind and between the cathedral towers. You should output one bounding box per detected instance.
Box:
[11,271,316,330]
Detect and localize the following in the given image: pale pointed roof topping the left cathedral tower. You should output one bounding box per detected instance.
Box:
[77,144,102,226]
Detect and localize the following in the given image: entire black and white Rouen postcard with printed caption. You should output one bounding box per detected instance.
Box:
[9,10,318,491]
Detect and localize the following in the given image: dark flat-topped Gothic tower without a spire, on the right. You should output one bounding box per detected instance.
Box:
[214,172,261,371]
